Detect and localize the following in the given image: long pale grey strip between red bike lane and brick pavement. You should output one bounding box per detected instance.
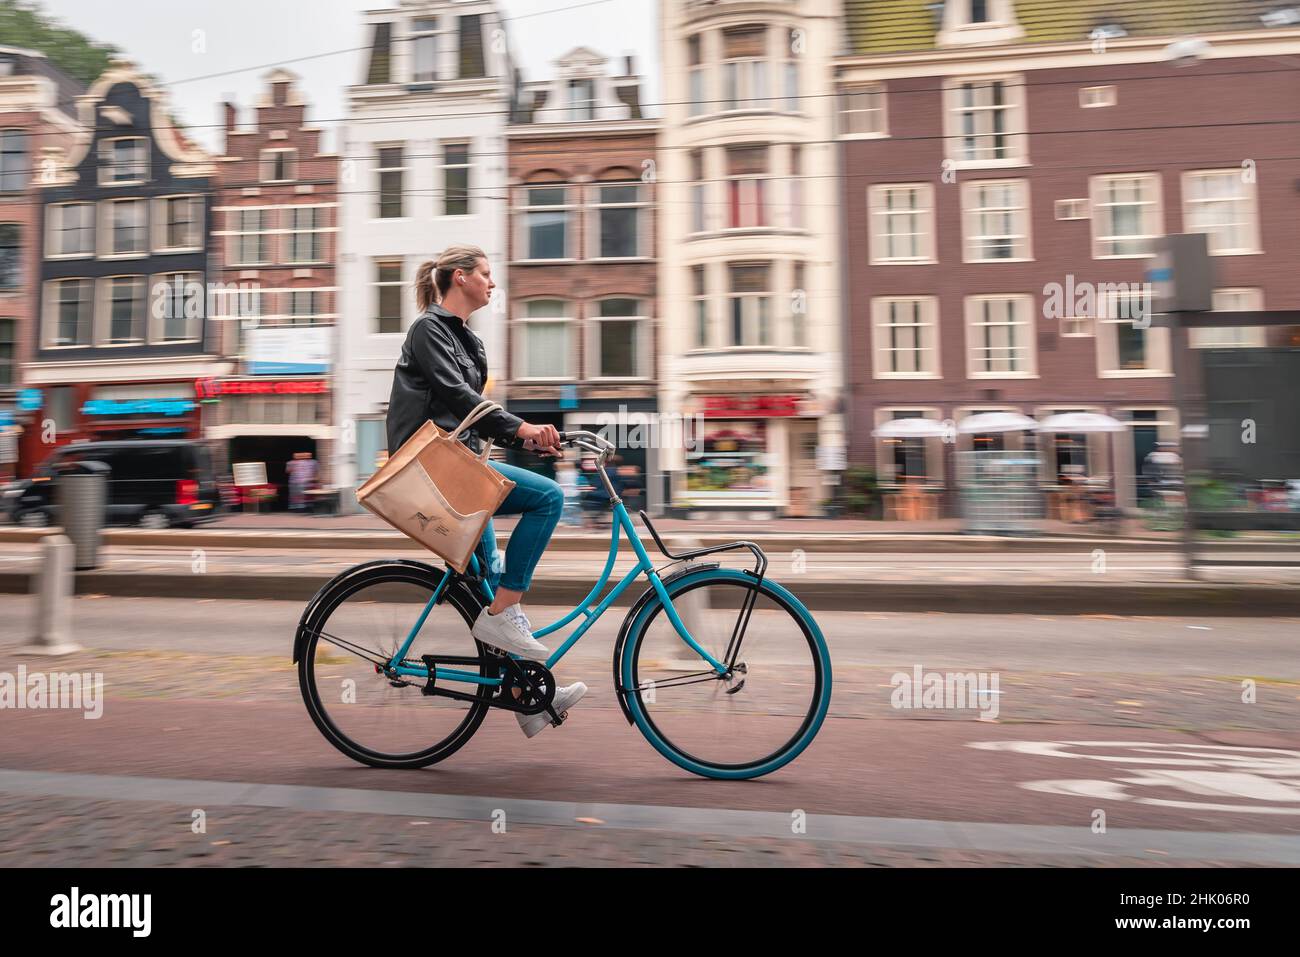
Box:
[0,770,1300,866]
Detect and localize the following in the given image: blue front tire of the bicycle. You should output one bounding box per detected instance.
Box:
[619,568,832,780]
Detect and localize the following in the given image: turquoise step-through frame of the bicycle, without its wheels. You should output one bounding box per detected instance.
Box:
[389,494,733,687]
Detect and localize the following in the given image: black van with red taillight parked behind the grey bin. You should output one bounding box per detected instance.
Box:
[8,439,221,528]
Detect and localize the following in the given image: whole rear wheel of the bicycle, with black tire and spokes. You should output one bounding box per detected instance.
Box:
[298,563,495,767]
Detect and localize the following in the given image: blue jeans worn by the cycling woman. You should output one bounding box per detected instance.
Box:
[478,462,564,592]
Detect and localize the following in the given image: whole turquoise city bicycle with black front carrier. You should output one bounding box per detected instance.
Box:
[294,432,831,779]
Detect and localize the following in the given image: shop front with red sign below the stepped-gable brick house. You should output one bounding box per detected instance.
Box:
[195,376,338,511]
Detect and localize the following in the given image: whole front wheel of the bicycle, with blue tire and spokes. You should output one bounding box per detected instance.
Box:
[620,568,831,779]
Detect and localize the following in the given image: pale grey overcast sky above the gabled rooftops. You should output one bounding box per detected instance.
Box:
[30,0,659,150]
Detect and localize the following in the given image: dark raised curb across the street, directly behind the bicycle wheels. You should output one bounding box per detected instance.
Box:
[0,571,1300,616]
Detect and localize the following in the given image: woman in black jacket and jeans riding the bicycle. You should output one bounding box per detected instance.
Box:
[387,246,586,737]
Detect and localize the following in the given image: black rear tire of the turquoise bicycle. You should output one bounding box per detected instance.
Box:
[298,562,493,768]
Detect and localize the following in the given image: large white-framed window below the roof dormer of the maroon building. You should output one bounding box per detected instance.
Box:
[944,77,1028,168]
